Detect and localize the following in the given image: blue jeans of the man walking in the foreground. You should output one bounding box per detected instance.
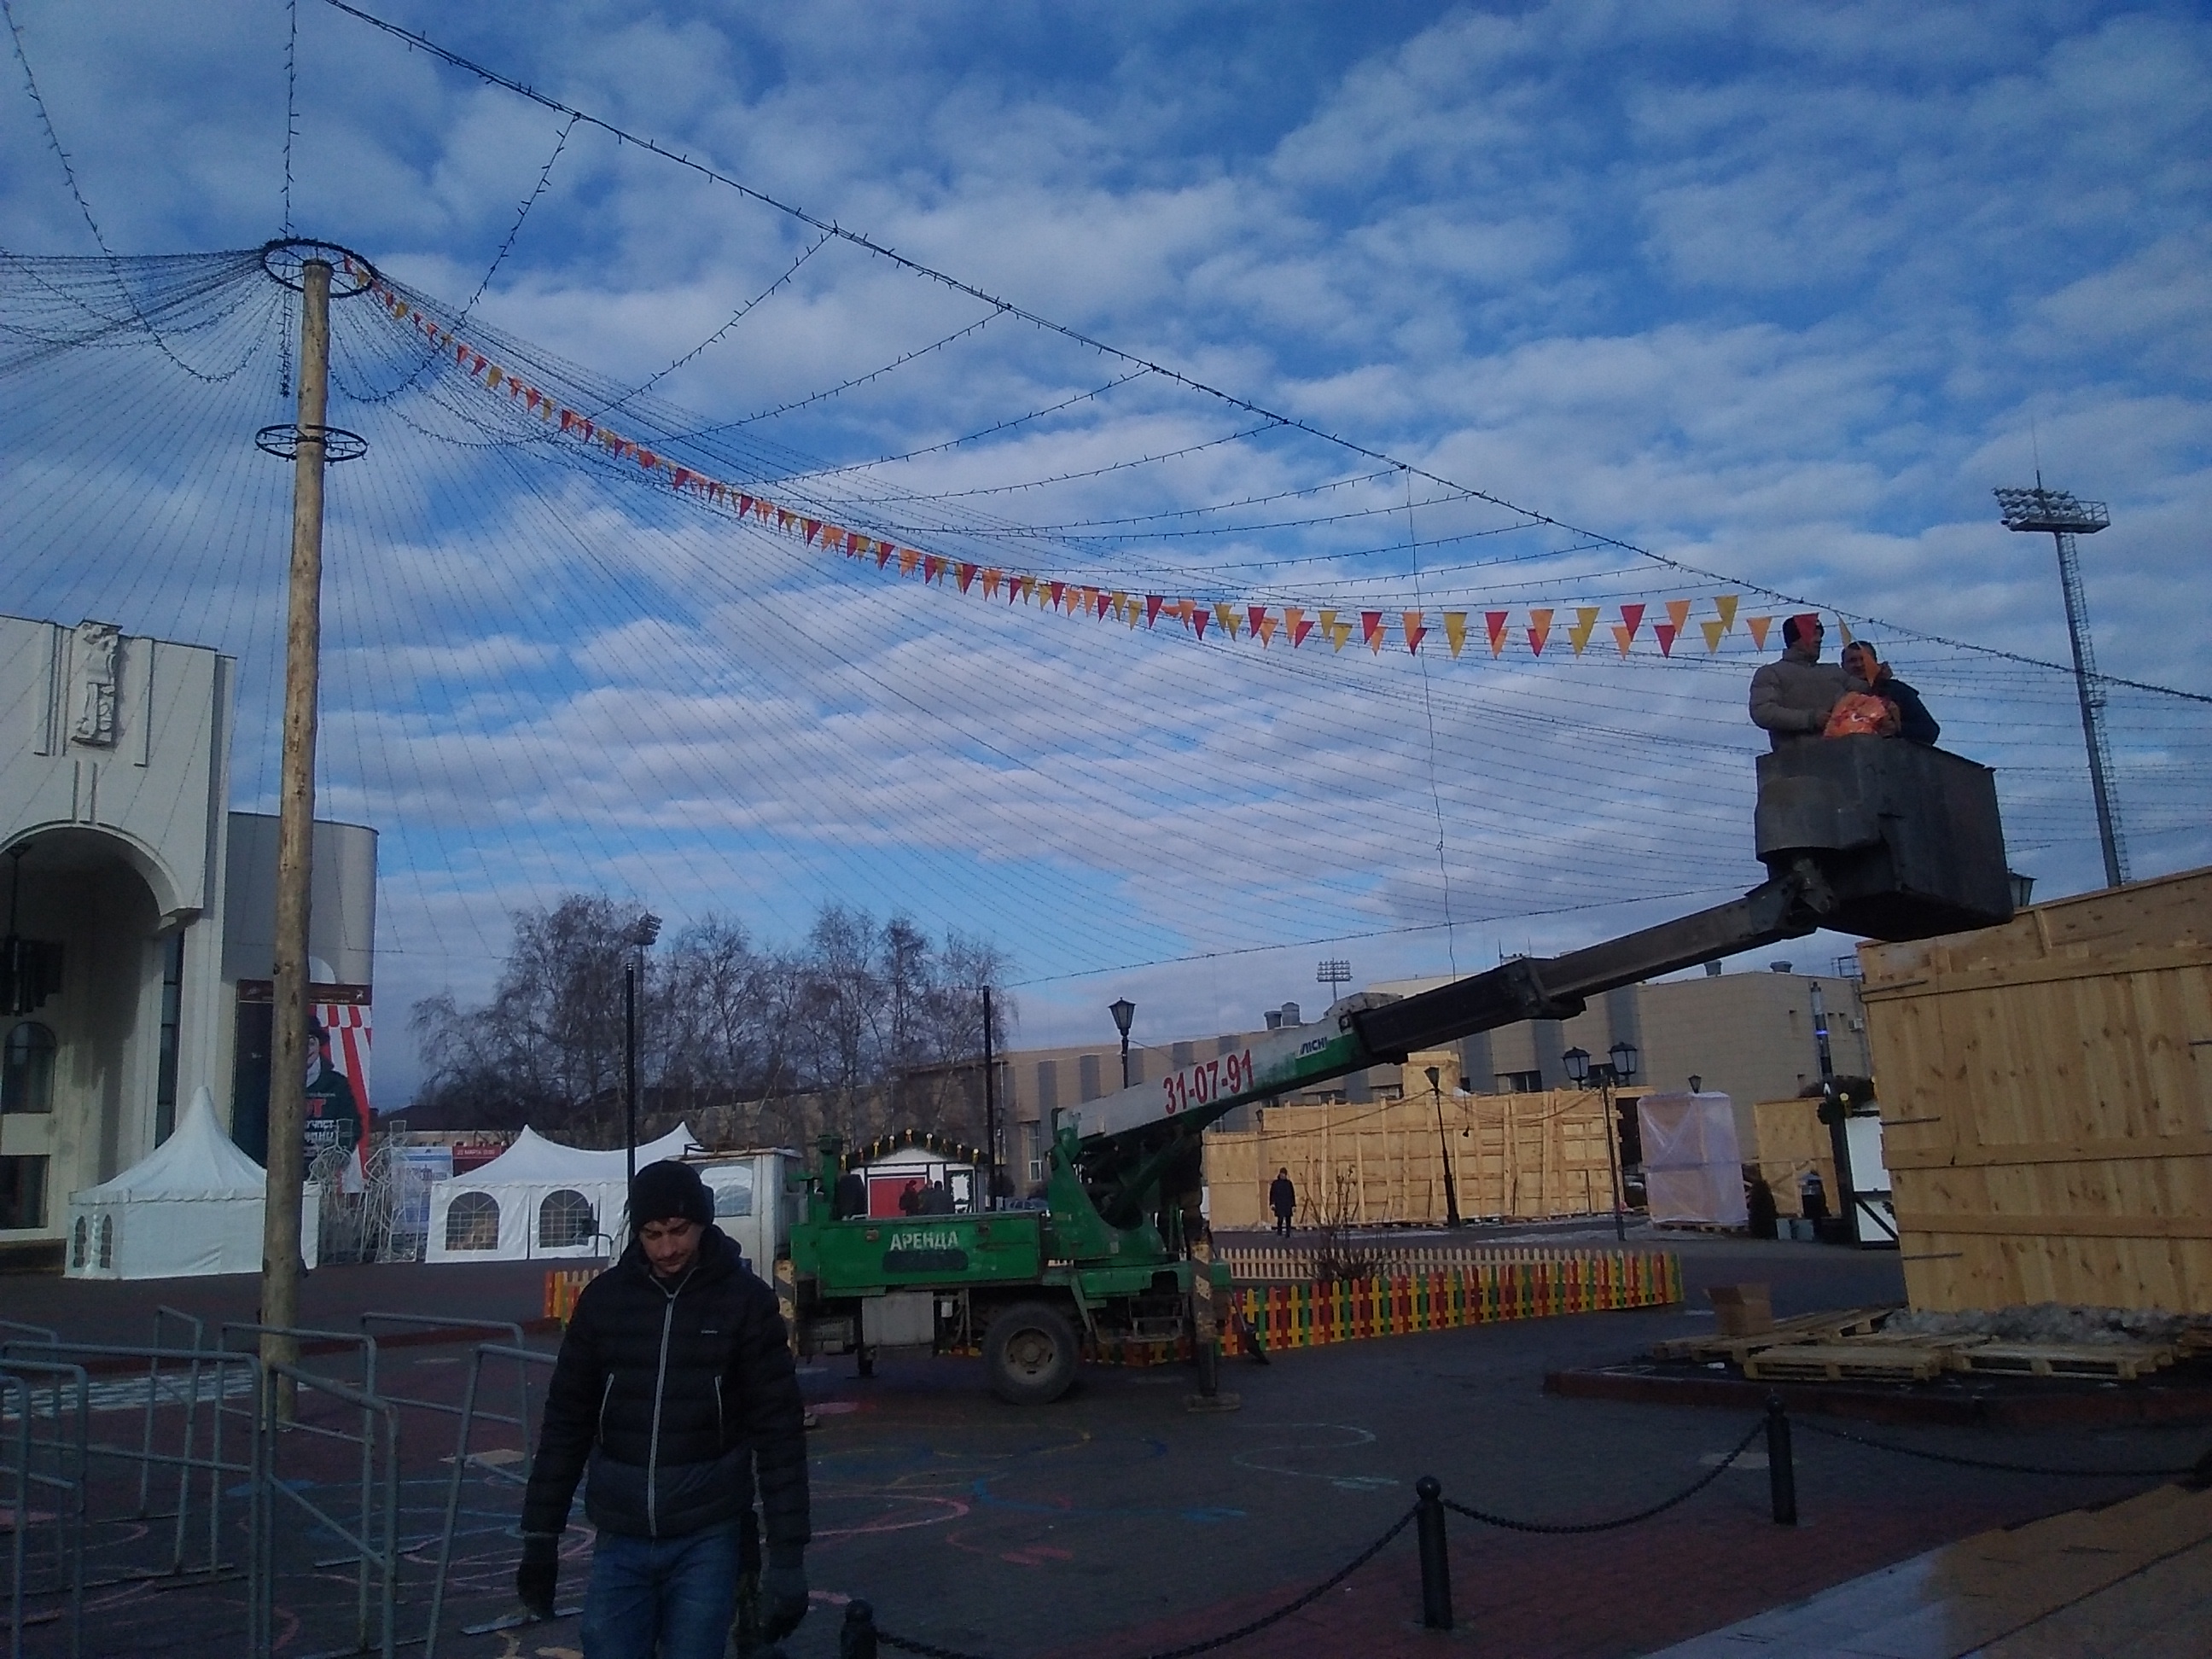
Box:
[584,1520,736,1659]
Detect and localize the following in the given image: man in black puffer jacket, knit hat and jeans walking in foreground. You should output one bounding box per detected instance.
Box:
[515,1161,807,1659]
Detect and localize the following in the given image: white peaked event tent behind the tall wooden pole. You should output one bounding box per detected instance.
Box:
[68,1086,321,1278]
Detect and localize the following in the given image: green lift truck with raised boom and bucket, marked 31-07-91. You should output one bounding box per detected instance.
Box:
[777,736,2013,1405]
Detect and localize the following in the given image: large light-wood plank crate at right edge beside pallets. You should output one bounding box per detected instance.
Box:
[1858,870,2212,1314]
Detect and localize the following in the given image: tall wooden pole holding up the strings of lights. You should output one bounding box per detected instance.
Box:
[261,259,332,1416]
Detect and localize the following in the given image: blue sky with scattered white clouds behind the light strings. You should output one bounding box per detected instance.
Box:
[0,0,2212,1103]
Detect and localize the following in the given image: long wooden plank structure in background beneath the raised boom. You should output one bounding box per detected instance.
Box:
[1206,1079,1613,1228]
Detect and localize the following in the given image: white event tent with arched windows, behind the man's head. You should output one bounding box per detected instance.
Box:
[425,1124,696,1260]
